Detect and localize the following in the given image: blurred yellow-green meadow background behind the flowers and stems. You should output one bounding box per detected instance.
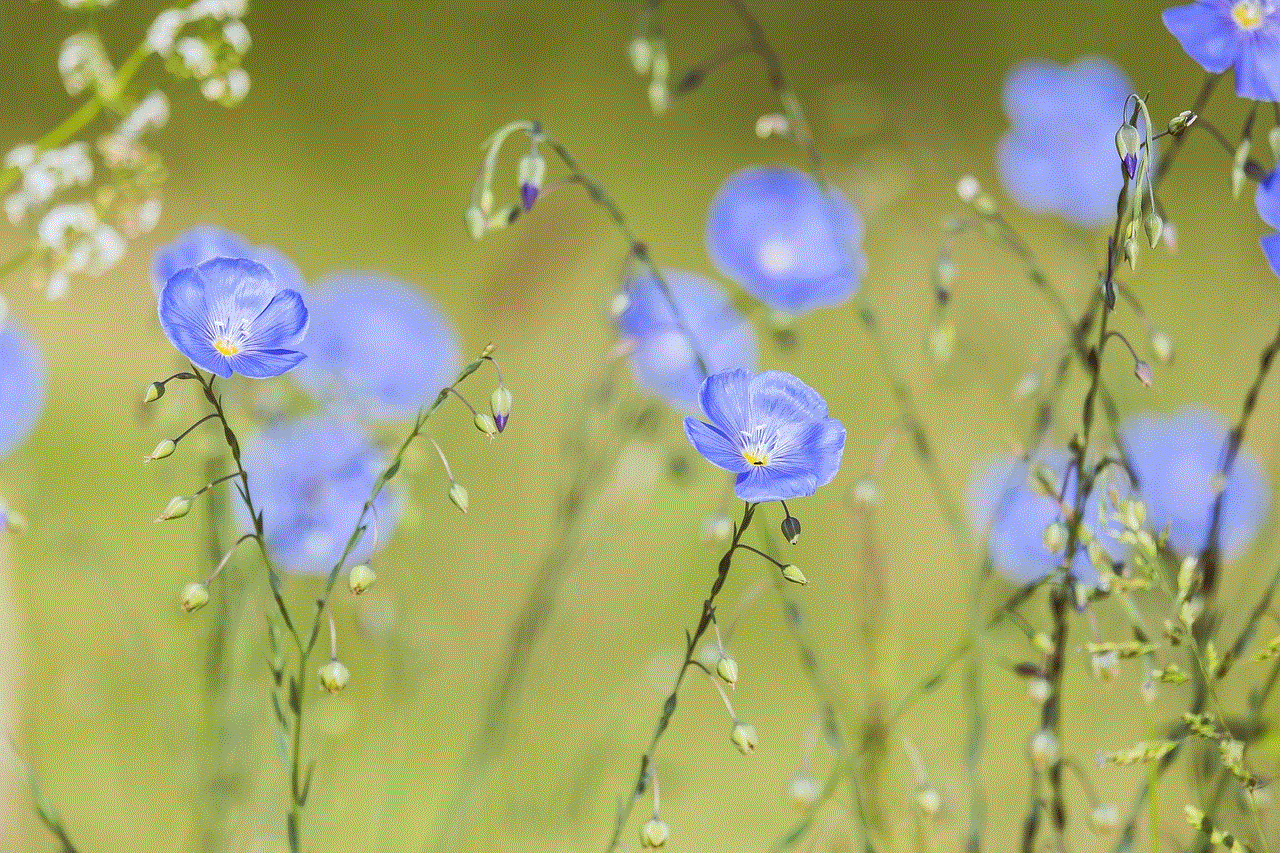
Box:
[0,1,1280,852]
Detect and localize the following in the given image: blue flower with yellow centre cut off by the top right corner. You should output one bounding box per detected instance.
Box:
[1161,0,1280,101]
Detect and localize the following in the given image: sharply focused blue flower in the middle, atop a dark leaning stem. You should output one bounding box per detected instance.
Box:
[685,369,845,503]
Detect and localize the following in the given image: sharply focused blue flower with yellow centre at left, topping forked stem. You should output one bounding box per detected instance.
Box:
[159,257,307,378]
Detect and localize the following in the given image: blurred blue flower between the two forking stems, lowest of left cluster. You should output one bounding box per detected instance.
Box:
[237,415,398,574]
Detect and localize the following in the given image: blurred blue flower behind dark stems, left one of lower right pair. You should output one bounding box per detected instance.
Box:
[968,450,1128,587]
